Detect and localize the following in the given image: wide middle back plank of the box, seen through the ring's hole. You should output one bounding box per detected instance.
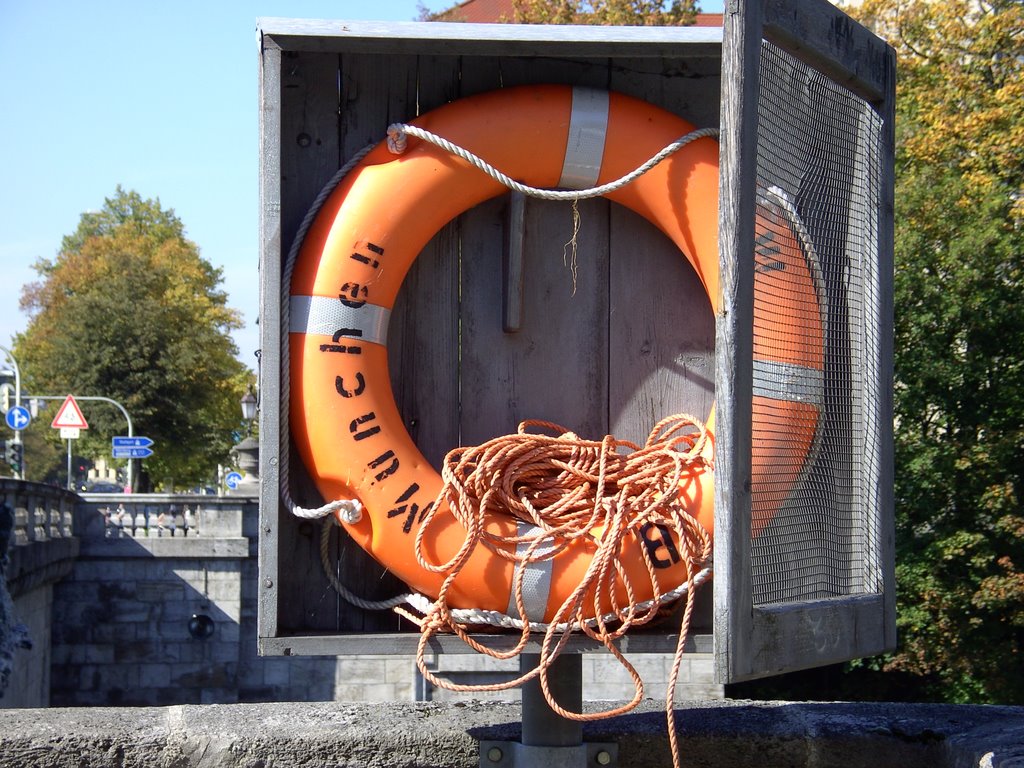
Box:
[461,193,607,444]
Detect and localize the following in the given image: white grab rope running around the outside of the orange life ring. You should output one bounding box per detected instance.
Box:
[279,118,719,632]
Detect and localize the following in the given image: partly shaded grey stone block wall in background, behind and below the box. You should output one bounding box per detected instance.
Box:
[46,496,723,707]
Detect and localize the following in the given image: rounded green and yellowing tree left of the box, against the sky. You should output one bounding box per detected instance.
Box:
[16,186,252,488]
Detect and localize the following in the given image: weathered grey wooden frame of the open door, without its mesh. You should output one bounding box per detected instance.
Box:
[714,0,896,683]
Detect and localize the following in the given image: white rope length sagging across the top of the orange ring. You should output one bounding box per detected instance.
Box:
[387,123,718,201]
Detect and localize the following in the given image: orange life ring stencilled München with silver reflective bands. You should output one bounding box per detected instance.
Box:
[290,86,821,621]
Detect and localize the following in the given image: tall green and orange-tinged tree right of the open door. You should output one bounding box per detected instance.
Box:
[853,0,1024,703]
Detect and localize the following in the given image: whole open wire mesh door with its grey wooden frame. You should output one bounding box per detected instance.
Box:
[716,3,894,681]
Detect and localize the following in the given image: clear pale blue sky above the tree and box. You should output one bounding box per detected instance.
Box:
[0,0,721,368]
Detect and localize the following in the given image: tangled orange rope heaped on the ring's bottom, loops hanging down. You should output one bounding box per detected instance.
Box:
[396,415,712,766]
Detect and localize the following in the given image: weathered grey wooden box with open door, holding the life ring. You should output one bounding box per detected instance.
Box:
[259,2,893,682]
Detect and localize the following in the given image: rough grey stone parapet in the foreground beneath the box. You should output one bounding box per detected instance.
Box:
[0,701,1024,768]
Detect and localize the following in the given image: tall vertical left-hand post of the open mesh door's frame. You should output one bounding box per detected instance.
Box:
[714,2,761,682]
